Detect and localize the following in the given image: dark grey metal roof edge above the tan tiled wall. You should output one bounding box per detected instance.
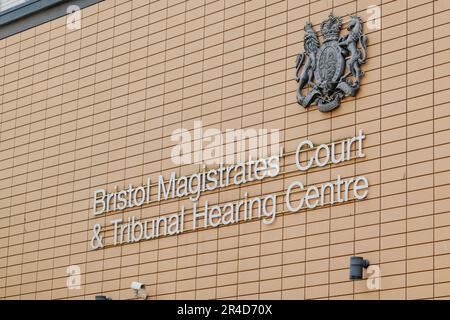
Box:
[0,0,103,39]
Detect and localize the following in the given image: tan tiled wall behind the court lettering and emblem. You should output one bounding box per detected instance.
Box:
[0,0,450,299]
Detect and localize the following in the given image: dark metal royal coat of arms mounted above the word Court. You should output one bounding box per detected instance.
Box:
[296,13,367,112]
